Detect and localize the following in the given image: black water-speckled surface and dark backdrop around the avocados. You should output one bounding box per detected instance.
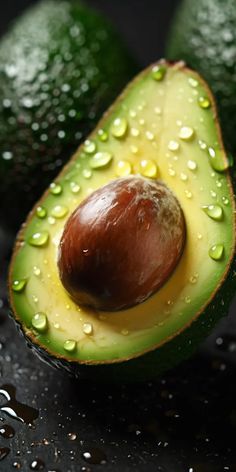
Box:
[0,0,236,472]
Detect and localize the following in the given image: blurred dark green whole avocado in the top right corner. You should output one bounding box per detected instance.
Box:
[166,0,236,153]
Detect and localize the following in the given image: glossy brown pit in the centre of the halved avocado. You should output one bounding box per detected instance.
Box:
[58,176,185,311]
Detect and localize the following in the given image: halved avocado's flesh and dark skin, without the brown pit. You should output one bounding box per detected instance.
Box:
[9,61,235,380]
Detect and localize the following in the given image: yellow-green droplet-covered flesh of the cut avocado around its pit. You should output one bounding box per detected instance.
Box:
[10,63,235,364]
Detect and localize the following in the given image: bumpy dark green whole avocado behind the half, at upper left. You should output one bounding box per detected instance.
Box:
[0,0,135,227]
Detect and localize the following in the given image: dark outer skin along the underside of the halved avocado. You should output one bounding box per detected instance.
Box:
[11,254,236,384]
